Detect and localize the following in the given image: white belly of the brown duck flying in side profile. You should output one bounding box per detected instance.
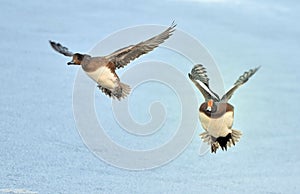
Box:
[86,66,118,90]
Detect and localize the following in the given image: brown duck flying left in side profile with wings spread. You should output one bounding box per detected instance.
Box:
[49,22,176,100]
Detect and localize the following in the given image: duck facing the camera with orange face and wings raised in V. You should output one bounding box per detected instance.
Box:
[188,64,260,153]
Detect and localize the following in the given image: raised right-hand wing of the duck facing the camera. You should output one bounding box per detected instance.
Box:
[221,66,260,102]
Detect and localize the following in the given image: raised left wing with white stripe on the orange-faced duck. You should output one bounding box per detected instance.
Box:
[188,64,220,101]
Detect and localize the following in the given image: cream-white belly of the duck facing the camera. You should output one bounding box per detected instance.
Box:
[199,111,233,138]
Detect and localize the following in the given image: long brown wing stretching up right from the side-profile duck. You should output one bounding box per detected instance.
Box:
[105,22,176,69]
